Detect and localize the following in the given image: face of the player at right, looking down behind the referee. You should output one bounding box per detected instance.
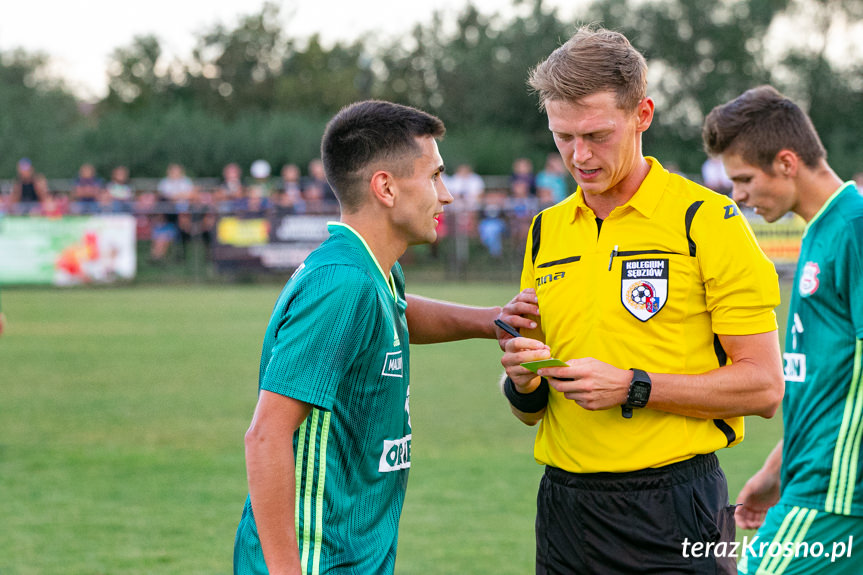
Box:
[721,152,795,222]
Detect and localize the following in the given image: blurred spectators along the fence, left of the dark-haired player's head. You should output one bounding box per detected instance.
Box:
[0,158,338,261]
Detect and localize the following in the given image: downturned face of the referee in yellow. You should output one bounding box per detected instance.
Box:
[545,92,653,201]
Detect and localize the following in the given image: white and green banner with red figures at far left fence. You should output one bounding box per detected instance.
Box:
[0,214,136,286]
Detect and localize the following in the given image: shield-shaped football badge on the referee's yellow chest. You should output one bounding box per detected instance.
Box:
[620,259,668,321]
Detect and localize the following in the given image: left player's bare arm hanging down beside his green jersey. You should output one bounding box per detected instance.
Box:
[245,390,311,575]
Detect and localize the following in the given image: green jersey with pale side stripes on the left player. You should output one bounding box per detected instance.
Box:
[234,223,411,575]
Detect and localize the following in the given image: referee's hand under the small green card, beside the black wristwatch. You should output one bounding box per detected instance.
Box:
[539,357,632,411]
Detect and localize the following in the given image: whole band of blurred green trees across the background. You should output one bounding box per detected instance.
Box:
[0,0,863,179]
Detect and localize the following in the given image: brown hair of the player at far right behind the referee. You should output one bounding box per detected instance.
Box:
[701,86,827,174]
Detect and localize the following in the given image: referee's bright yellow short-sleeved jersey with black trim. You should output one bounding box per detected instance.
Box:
[521,158,779,473]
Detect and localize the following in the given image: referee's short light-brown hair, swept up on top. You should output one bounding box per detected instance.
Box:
[528,26,647,111]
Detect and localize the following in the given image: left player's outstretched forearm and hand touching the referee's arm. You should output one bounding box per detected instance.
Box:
[405,290,539,343]
